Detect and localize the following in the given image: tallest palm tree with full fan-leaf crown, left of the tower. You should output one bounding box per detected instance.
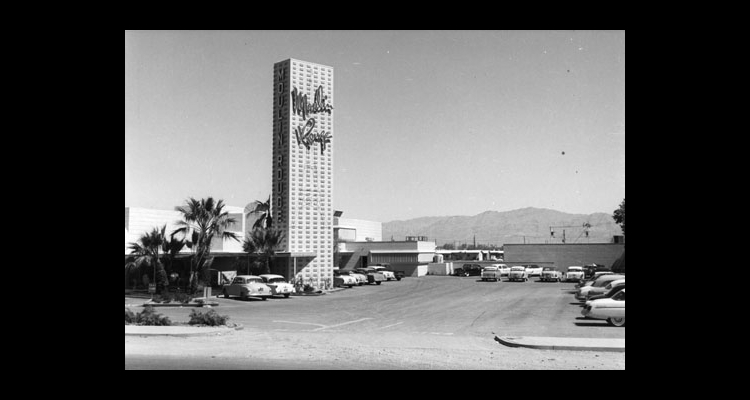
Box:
[172,197,240,291]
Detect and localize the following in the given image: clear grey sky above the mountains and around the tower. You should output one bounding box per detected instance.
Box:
[125,31,625,222]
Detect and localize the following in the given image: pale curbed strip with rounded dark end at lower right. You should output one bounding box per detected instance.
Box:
[495,336,625,353]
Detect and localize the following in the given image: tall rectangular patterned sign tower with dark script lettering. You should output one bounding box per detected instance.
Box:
[271,59,334,287]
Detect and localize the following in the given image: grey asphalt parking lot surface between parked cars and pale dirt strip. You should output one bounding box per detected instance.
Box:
[128,276,625,338]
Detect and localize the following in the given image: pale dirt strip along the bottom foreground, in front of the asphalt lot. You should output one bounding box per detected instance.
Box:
[125,328,625,370]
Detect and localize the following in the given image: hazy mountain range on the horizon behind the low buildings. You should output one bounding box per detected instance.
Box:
[383,207,622,246]
